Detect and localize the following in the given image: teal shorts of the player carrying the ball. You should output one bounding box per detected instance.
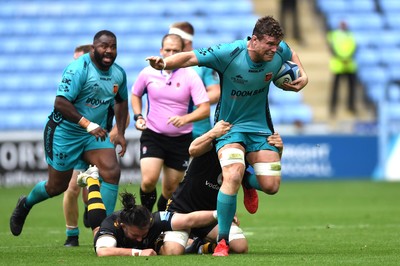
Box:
[216,132,278,153]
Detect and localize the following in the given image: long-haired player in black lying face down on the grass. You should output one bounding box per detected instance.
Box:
[78,166,216,256]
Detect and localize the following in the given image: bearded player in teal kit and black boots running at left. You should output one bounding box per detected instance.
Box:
[10,30,128,236]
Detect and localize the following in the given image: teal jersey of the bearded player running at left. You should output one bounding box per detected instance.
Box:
[57,54,128,132]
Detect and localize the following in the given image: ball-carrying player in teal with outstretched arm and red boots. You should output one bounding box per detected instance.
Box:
[146,16,308,256]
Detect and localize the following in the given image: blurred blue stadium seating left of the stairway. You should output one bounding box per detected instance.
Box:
[0,0,311,130]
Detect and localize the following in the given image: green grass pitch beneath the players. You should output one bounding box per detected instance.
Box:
[0,181,400,266]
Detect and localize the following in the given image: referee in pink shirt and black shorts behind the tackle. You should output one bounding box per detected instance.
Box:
[131,34,210,211]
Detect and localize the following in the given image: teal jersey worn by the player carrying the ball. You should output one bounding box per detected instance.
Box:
[194,39,292,135]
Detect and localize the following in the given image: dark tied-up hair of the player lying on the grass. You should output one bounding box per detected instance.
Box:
[119,191,152,229]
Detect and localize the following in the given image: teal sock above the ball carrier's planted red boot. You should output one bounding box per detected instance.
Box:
[217,190,237,243]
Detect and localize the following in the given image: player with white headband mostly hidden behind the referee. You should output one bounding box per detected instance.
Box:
[169,21,221,139]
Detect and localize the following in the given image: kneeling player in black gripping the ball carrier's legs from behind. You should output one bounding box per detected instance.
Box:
[161,120,283,255]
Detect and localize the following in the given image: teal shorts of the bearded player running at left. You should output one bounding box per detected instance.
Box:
[44,120,114,171]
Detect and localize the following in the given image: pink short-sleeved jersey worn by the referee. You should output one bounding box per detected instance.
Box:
[132,66,209,137]
